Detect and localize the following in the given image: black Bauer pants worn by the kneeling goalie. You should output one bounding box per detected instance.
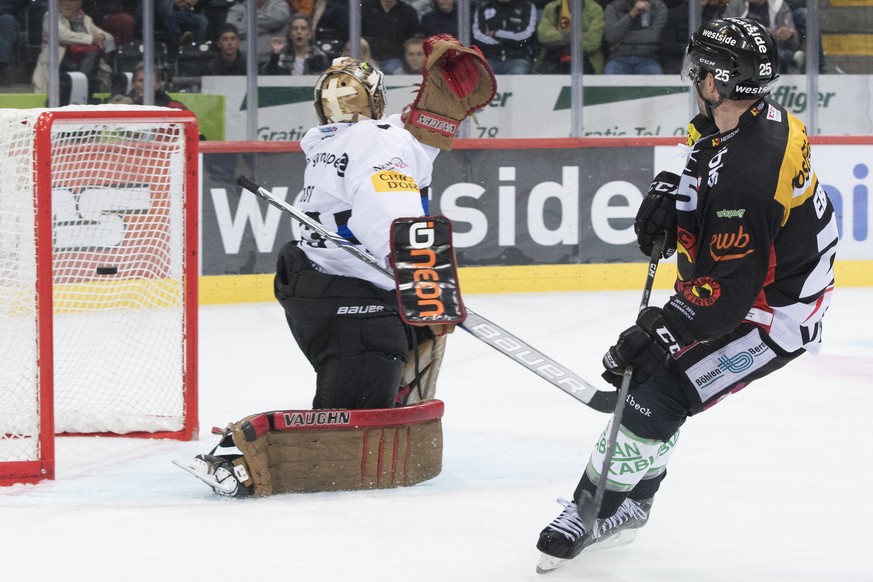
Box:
[274,243,413,409]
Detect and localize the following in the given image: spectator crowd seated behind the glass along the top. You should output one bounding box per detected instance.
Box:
[0,0,823,101]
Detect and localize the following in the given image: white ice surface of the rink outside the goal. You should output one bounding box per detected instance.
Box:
[0,288,873,582]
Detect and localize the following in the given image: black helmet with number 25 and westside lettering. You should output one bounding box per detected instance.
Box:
[682,18,779,99]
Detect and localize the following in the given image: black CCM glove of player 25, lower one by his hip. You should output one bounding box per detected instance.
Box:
[603,307,681,388]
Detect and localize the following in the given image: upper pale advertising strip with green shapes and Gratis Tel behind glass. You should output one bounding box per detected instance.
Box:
[202,75,873,141]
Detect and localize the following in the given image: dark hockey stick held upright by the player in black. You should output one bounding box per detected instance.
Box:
[576,234,667,537]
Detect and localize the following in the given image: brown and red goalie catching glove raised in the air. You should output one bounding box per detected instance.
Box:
[403,34,497,150]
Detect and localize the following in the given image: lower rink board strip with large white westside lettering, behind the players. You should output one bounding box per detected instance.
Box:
[201,139,873,294]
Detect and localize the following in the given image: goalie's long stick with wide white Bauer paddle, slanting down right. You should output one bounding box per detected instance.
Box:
[237,176,616,413]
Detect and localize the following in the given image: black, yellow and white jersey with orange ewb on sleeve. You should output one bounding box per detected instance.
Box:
[665,98,838,352]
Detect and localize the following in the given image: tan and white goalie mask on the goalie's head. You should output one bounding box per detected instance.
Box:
[315,57,385,124]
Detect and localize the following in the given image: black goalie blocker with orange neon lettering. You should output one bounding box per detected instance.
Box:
[391,216,467,325]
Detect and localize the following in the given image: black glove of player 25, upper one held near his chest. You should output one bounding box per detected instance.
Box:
[634,171,679,259]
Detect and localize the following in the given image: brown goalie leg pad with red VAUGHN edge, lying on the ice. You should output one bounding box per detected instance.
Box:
[229,400,444,496]
